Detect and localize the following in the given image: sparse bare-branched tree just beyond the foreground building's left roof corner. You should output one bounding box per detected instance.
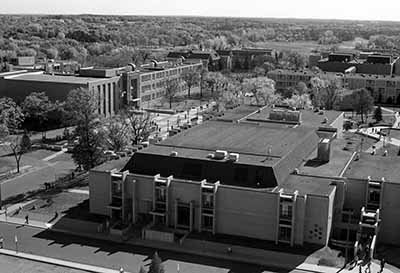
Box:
[123,111,152,145]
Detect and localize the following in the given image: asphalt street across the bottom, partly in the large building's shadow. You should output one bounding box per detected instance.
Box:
[0,222,277,273]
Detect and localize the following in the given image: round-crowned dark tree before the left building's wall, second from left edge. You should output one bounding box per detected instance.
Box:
[22,92,53,136]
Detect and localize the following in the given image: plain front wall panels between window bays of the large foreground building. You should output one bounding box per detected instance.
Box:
[89,171,335,245]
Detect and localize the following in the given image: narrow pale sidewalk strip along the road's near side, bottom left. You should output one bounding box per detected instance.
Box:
[0,246,129,273]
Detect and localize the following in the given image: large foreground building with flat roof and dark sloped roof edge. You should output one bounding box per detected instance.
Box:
[89,108,343,245]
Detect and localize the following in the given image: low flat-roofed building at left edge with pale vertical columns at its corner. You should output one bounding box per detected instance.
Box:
[0,69,122,116]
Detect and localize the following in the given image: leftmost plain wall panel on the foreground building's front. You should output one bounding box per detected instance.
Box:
[89,171,111,216]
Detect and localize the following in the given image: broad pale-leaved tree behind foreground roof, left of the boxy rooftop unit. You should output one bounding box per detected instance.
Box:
[243,77,279,105]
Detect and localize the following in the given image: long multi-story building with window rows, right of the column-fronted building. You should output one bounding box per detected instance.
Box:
[122,61,203,107]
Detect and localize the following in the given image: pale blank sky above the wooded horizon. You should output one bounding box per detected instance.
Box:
[0,0,400,21]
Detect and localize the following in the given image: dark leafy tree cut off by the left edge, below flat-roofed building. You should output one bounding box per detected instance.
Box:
[0,97,25,135]
